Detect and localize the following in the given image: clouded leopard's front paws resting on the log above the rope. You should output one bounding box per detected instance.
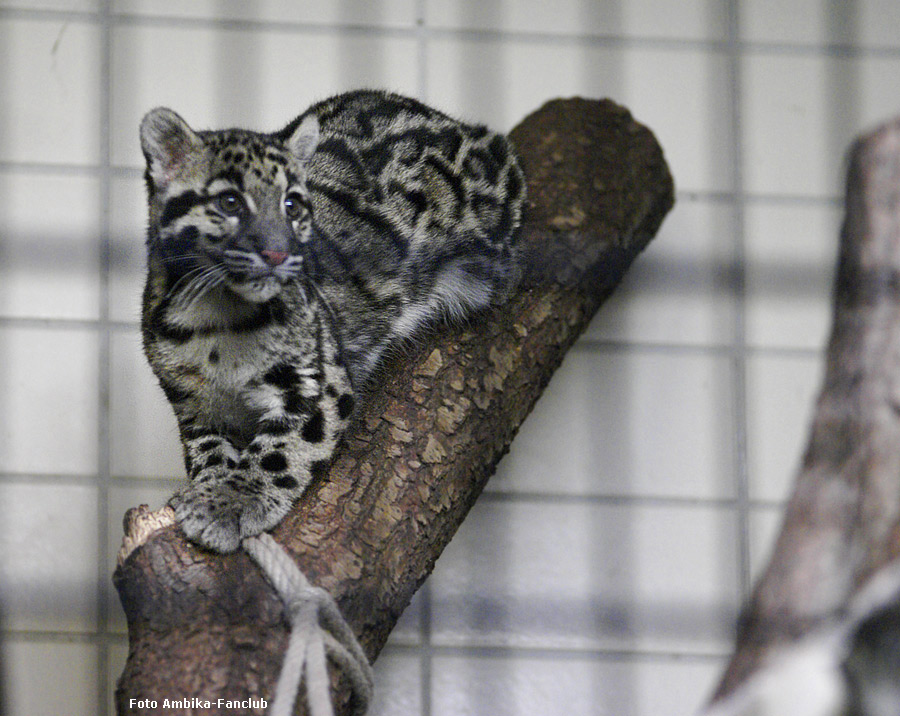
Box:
[169,475,292,553]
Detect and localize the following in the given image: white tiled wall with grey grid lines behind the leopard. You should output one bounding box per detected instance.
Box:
[0,0,900,716]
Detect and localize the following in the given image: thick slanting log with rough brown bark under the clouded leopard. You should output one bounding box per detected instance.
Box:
[114,99,673,716]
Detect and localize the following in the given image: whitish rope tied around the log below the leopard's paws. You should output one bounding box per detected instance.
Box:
[242,533,374,716]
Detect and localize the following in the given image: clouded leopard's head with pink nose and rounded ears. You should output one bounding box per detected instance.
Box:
[141,108,319,303]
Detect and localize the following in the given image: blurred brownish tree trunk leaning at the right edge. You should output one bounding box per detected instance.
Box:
[715,120,900,699]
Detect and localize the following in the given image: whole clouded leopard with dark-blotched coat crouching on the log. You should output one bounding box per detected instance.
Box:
[140,90,525,552]
